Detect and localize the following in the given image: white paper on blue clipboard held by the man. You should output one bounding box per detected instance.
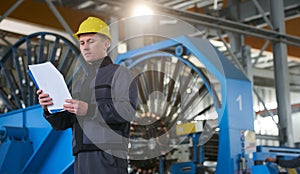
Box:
[28,62,72,113]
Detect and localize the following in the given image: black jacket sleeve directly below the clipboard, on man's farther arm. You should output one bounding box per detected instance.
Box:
[44,111,76,130]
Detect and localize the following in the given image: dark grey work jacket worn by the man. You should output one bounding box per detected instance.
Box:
[44,57,138,155]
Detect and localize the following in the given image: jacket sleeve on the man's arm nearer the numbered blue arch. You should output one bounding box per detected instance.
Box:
[97,67,138,124]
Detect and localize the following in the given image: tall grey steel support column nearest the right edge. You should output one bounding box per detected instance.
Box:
[270,1,294,147]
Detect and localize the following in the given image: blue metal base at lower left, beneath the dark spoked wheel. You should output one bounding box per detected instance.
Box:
[0,105,74,174]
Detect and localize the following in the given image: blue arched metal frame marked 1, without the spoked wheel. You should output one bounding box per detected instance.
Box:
[116,36,254,174]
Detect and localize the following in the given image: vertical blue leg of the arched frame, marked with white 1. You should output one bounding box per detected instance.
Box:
[216,79,254,173]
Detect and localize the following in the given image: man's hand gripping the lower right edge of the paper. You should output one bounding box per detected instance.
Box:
[64,99,89,116]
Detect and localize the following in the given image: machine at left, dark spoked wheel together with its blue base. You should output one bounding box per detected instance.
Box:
[0,32,84,173]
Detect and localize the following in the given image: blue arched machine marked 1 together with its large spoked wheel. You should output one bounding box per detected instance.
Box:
[116,36,255,173]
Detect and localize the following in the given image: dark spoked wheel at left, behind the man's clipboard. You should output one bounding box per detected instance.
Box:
[0,32,84,113]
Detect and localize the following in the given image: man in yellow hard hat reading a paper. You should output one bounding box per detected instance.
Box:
[37,17,138,174]
